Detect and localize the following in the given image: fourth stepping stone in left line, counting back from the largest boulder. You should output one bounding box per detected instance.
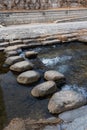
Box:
[10,61,34,72]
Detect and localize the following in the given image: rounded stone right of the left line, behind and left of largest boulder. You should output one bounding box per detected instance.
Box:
[44,70,65,82]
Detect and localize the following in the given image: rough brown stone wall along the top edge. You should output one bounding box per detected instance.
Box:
[0,0,87,10]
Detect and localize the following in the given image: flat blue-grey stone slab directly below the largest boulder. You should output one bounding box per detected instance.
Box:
[58,105,87,122]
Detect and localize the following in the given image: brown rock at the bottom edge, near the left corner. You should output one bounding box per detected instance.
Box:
[4,118,26,130]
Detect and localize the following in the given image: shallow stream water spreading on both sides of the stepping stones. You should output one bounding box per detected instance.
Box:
[0,43,87,130]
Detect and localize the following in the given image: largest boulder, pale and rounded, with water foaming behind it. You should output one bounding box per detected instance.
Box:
[48,90,87,114]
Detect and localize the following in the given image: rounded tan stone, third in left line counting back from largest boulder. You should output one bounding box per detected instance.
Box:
[17,70,40,84]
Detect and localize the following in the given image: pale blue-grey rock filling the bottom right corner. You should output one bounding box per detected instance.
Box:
[66,114,87,130]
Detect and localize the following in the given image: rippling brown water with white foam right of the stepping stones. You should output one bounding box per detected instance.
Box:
[39,43,87,96]
